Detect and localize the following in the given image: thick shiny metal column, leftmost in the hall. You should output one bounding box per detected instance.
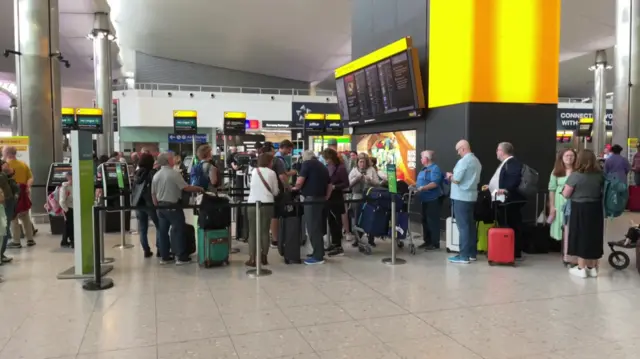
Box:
[14,0,62,208]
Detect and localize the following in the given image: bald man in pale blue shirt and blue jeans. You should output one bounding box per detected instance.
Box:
[447,140,482,264]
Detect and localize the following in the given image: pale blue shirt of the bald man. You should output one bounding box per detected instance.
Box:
[450,153,482,202]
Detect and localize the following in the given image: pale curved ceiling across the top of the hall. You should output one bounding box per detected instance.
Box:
[0,0,615,115]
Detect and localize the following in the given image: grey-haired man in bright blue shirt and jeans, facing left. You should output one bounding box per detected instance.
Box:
[416,151,444,251]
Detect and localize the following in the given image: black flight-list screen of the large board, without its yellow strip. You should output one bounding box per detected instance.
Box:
[336,45,422,122]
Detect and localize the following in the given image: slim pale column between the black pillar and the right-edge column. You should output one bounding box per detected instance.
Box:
[592,50,607,154]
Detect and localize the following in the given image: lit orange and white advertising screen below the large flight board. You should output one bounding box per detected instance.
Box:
[356,130,417,185]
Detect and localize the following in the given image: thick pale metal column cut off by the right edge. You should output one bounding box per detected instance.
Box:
[613,0,640,148]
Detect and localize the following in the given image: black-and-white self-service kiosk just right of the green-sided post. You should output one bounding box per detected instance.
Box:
[97,162,131,233]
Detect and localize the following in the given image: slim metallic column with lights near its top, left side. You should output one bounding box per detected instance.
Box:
[91,12,114,156]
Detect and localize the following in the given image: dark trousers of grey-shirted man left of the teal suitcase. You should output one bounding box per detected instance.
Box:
[158,202,189,260]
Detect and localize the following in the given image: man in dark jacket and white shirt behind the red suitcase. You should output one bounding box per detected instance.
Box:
[488,142,525,259]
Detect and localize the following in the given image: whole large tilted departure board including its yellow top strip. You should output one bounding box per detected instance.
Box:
[335,37,425,125]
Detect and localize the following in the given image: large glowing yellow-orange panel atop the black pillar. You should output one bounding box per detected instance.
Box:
[428,0,560,108]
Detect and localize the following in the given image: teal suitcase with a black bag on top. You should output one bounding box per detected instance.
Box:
[198,228,231,268]
